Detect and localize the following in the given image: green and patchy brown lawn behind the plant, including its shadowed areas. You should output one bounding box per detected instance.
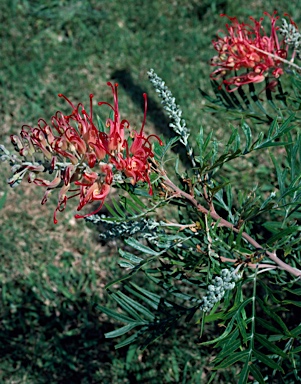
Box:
[0,0,301,384]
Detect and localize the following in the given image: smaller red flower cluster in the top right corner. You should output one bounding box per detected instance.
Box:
[211,12,293,91]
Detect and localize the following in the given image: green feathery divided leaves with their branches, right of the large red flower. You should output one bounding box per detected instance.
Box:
[84,68,301,384]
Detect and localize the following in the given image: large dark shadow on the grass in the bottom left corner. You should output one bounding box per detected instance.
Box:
[0,279,213,384]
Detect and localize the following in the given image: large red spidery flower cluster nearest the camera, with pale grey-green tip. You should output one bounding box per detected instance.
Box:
[6,83,162,223]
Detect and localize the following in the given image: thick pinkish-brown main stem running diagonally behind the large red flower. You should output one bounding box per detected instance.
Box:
[162,173,301,277]
